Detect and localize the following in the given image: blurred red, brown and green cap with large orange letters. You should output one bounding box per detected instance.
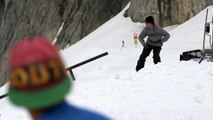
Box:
[8,37,72,110]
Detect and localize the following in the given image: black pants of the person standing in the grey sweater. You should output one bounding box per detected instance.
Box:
[136,45,161,71]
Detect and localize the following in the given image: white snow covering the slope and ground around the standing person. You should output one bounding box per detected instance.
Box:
[0,6,213,120]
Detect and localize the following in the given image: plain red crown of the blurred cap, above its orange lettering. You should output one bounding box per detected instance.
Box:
[9,37,59,67]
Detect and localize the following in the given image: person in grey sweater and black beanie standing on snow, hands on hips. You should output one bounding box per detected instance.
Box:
[136,16,170,72]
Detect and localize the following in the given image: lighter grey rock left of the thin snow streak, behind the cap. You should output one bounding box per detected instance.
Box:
[0,0,63,86]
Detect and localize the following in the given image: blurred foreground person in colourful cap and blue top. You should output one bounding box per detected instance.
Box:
[8,37,109,120]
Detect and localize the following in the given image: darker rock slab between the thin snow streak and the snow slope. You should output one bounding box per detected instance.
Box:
[56,0,125,48]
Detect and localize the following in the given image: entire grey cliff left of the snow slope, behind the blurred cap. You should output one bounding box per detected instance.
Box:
[0,0,129,86]
